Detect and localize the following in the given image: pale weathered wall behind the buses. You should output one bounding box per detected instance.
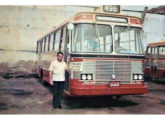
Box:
[0,6,165,64]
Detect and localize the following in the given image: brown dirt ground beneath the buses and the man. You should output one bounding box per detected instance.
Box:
[0,61,165,115]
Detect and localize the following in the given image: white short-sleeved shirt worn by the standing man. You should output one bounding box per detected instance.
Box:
[49,60,68,81]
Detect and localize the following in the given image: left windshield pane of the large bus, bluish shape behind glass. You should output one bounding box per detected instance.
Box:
[72,24,112,53]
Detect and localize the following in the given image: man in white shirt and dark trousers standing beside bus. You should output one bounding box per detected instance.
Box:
[49,52,69,109]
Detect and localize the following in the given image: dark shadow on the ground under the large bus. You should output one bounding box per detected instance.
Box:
[64,96,138,109]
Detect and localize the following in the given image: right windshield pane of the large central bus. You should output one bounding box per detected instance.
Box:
[114,26,143,54]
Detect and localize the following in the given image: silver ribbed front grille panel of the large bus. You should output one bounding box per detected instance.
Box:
[83,61,142,84]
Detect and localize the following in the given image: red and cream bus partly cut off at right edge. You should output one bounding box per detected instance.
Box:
[144,40,165,81]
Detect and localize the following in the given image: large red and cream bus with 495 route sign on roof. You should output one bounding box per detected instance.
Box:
[36,6,148,96]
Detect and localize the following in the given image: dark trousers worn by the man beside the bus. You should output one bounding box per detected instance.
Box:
[53,81,65,107]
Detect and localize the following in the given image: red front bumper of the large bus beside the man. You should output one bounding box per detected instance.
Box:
[69,85,148,96]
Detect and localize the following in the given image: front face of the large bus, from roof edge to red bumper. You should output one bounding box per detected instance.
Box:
[65,7,147,96]
